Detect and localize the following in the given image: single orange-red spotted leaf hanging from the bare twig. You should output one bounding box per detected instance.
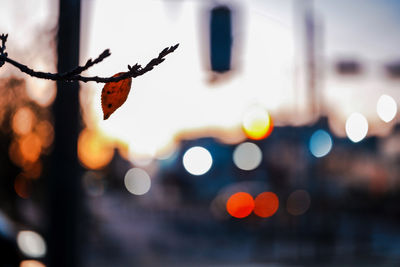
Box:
[101,72,132,120]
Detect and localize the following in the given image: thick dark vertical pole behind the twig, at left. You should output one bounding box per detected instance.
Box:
[48,0,81,267]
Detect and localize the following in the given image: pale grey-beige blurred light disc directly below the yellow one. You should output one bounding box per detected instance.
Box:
[233,142,262,171]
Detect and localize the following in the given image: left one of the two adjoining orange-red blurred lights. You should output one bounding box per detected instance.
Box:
[226,192,254,218]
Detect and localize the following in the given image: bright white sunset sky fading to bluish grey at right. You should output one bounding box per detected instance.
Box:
[0,0,400,159]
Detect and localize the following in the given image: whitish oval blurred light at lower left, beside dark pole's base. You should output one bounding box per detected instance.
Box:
[17,231,46,258]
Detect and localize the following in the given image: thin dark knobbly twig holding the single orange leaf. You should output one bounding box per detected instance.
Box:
[0,34,179,83]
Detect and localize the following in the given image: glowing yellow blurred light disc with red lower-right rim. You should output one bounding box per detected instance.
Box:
[243,107,274,140]
